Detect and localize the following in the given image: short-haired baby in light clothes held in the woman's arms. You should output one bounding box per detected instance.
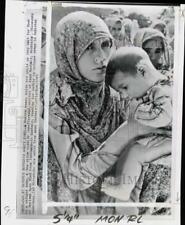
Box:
[102,47,172,201]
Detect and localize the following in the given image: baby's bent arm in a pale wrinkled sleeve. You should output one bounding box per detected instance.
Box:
[135,87,172,128]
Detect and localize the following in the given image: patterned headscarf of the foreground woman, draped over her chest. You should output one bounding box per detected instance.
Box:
[50,11,123,151]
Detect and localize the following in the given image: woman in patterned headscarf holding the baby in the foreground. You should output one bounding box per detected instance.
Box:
[38,11,169,215]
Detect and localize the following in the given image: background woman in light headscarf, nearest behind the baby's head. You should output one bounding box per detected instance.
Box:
[134,28,170,74]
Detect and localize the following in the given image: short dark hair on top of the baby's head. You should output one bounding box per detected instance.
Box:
[105,47,150,85]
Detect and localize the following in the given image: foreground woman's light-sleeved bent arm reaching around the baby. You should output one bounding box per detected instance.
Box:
[49,118,167,190]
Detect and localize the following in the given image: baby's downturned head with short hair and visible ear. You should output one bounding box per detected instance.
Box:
[106,47,155,98]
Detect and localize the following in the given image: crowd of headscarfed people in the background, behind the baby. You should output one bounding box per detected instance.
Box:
[105,10,174,74]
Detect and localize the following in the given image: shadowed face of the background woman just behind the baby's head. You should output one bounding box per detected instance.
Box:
[143,37,164,68]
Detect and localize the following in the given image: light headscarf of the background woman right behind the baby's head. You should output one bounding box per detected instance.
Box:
[134,28,170,70]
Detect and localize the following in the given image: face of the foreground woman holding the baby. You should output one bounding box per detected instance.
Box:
[77,38,112,82]
